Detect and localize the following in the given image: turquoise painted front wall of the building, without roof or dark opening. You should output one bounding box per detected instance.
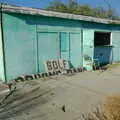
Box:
[3,13,120,80]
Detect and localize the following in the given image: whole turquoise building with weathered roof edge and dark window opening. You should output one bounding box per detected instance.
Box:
[0,5,120,81]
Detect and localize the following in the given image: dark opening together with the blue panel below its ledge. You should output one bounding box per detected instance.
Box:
[94,31,112,64]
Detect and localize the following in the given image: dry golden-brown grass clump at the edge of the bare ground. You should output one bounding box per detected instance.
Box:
[79,95,120,120]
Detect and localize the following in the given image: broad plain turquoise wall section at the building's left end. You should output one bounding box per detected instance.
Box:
[3,14,37,80]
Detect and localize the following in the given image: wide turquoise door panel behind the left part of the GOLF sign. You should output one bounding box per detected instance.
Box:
[38,32,60,72]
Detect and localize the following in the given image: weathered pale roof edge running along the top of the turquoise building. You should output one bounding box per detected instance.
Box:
[2,4,120,24]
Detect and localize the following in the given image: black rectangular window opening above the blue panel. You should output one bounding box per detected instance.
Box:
[94,32,111,46]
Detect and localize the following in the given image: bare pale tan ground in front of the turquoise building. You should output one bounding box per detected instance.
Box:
[0,65,120,120]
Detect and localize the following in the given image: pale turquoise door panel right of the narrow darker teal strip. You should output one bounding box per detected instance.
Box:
[70,33,82,68]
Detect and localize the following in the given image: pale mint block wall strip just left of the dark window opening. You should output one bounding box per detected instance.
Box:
[83,29,94,70]
